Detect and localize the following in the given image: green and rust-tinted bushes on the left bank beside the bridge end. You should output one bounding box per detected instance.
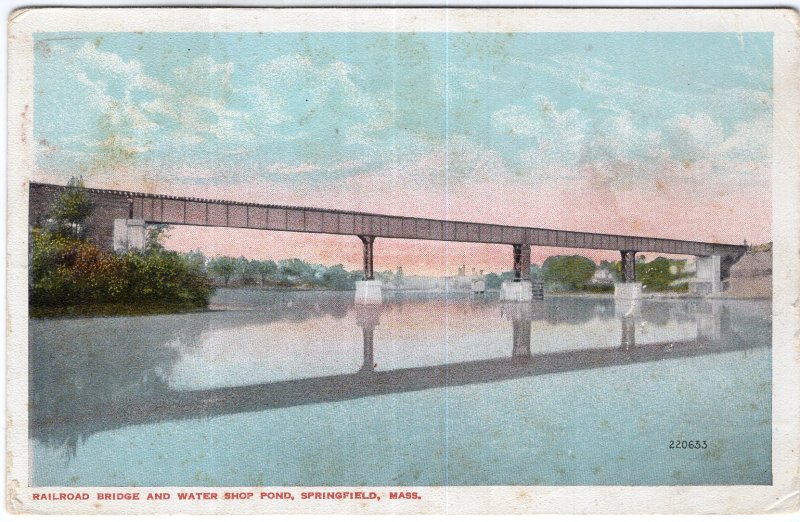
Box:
[29,188,211,313]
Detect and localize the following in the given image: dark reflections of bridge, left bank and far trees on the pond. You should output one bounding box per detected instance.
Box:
[31,294,756,443]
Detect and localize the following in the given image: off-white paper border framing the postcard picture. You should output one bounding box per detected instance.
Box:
[6,8,800,513]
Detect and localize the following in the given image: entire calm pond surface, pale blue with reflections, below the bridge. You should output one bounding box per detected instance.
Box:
[30,290,771,486]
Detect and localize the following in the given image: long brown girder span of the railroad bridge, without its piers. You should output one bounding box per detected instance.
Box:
[32,184,747,258]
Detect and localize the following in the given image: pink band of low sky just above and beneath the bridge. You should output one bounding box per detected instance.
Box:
[39,155,772,275]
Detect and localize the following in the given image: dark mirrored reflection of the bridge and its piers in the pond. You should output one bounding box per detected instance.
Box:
[30,294,752,447]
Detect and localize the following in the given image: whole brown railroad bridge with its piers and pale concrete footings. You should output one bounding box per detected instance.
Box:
[29,183,747,303]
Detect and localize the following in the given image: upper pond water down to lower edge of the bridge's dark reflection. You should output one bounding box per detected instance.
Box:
[29,291,770,482]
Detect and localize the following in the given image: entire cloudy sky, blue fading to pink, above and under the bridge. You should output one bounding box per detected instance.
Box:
[33,33,772,274]
